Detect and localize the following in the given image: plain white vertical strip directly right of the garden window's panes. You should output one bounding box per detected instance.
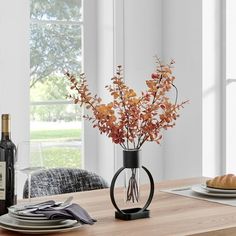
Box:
[82,0,98,173]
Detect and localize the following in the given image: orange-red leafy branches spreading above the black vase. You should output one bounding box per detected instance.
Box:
[66,58,187,149]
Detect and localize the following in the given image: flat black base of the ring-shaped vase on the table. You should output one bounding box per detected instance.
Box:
[115,208,150,220]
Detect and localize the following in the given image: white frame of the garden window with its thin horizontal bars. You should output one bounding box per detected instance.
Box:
[29,0,98,172]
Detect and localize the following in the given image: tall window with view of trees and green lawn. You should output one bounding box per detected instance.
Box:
[30,0,83,167]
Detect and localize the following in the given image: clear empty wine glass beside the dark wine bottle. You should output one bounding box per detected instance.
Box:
[16,141,44,201]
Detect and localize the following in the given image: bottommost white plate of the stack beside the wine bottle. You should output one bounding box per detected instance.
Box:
[0,223,82,234]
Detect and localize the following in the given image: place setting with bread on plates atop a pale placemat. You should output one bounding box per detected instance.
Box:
[160,174,236,206]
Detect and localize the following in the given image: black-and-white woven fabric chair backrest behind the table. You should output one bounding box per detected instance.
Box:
[23,168,108,198]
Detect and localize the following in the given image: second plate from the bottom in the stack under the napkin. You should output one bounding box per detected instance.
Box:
[0,214,78,230]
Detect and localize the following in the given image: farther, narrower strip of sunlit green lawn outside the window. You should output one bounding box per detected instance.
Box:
[30,129,81,141]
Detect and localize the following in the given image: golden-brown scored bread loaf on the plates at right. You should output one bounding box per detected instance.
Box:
[206,174,236,189]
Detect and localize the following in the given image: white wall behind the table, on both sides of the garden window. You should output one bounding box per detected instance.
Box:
[0,0,212,190]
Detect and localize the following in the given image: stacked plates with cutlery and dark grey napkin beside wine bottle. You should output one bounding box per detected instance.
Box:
[0,197,96,234]
